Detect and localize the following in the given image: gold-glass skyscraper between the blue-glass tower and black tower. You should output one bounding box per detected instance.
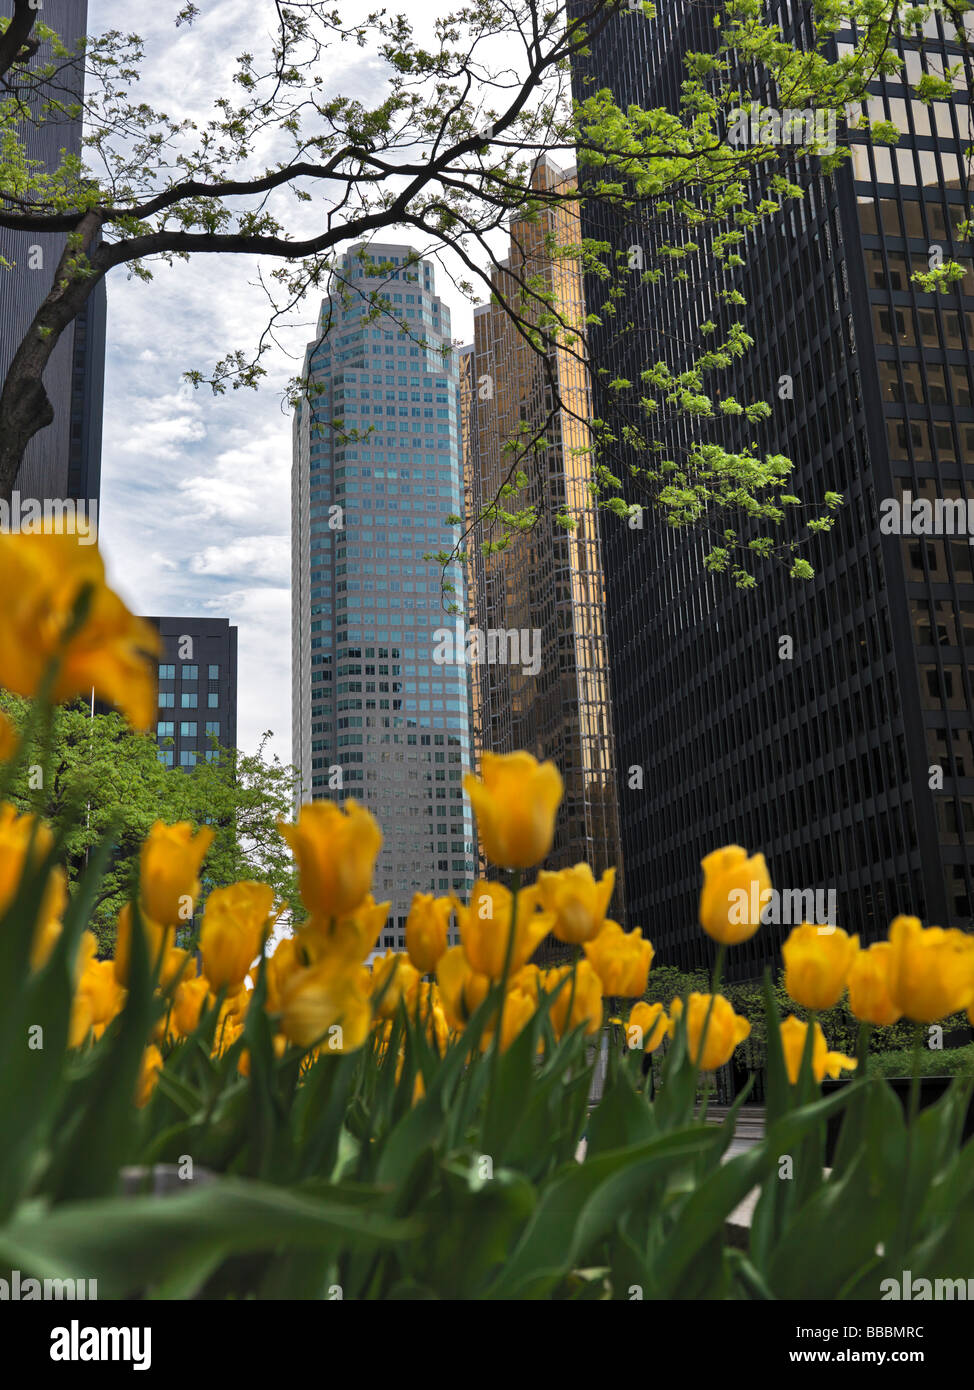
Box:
[463,158,622,915]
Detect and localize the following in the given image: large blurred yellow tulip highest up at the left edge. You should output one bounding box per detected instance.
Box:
[0,532,161,728]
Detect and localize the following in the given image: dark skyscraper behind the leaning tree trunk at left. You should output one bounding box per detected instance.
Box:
[0,0,106,502]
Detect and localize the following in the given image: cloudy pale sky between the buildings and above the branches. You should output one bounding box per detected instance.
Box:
[89,0,471,759]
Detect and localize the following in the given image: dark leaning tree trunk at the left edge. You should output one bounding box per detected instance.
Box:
[0,213,106,502]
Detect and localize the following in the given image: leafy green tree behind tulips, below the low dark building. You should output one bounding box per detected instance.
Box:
[0,692,299,949]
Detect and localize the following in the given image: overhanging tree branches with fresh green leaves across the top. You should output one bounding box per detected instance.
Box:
[0,0,953,582]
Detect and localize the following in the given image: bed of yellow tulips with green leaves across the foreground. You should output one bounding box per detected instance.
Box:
[0,537,974,1300]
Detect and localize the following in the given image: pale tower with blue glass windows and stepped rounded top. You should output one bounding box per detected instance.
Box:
[292,243,474,947]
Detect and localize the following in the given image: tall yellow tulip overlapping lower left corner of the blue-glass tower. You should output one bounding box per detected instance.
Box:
[278,801,382,919]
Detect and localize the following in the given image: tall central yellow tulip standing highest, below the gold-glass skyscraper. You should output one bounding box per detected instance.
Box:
[463,753,564,869]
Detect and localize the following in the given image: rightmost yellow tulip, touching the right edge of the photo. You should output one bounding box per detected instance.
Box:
[889,917,974,1023]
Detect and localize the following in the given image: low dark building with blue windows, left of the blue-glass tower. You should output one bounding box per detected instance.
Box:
[146,617,236,770]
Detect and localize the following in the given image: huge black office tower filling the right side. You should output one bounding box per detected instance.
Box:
[575,0,974,979]
